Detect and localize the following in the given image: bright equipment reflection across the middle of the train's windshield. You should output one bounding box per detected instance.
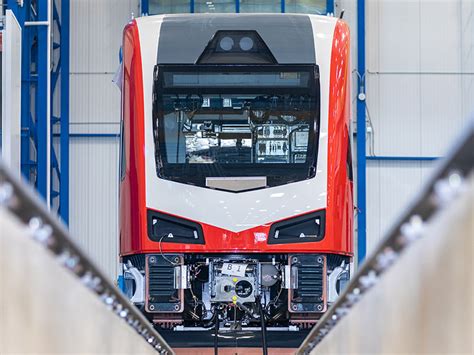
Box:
[163,95,311,164]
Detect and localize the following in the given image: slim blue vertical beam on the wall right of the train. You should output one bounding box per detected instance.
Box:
[357,0,367,265]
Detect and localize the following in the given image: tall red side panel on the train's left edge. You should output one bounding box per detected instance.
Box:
[120,21,146,254]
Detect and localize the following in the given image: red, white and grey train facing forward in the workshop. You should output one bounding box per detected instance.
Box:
[119,14,354,346]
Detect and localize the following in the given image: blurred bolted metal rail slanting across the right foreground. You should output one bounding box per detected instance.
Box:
[297,118,474,354]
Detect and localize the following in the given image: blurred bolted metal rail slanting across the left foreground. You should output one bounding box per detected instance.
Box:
[0,163,174,354]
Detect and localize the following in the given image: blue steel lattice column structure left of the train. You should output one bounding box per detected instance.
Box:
[8,0,69,223]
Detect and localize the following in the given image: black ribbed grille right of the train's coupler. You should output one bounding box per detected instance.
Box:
[291,255,326,312]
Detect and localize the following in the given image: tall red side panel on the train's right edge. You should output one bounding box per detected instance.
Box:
[326,20,353,252]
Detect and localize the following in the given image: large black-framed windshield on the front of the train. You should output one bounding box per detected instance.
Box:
[154,66,319,191]
